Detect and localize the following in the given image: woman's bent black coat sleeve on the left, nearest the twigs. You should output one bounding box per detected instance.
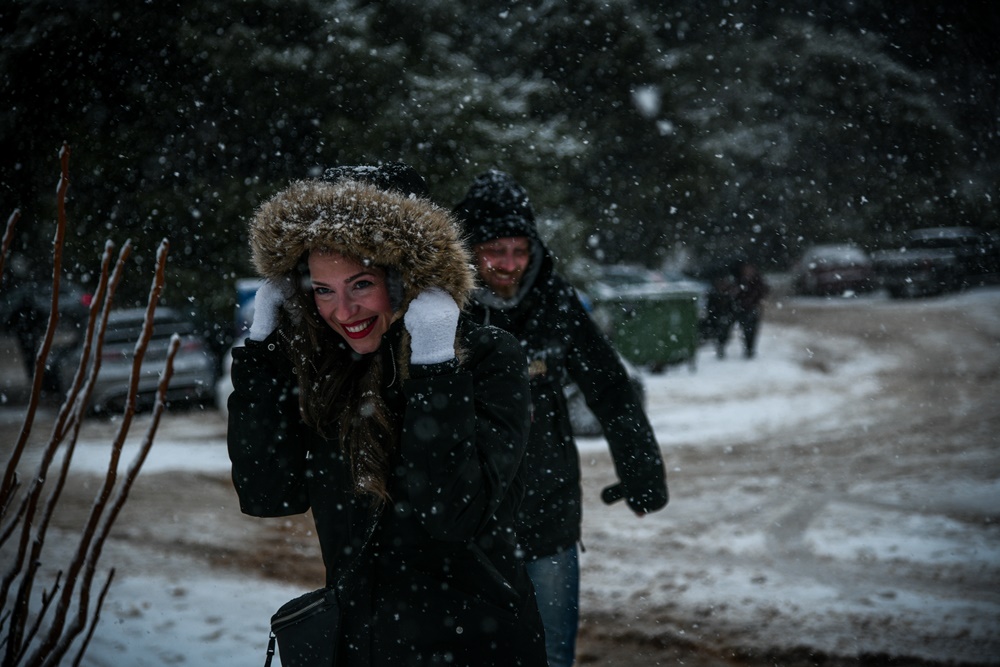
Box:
[227,334,309,517]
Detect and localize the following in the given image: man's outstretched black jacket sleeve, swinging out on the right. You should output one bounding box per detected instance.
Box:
[567,290,669,514]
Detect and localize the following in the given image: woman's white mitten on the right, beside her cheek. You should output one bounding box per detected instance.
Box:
[403,287,458,364]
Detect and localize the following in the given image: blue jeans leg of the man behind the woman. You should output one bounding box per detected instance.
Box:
[527,544,580,667]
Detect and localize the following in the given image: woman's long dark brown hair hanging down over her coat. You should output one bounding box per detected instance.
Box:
[285,262,399,503]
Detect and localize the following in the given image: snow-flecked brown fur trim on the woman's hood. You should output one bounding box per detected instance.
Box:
[250,180,475,315]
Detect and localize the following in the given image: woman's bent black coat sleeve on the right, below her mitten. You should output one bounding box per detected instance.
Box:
[400,327,531,541]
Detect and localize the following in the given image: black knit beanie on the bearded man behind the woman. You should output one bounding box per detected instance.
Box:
[452,169,538,245]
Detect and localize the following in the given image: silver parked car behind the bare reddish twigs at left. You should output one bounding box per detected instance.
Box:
[59,306,216,412]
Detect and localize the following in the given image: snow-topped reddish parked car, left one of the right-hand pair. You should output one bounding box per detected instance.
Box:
[792,244,878,296]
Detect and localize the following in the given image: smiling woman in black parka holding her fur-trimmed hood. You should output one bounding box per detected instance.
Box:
[228,164,545,667]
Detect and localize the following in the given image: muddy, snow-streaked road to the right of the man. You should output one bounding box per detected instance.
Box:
[583,290,1000,665]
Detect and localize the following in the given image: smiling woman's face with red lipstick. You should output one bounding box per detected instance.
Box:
[309,252,392,354]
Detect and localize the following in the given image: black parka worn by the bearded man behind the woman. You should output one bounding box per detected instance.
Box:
[468,248,668,560]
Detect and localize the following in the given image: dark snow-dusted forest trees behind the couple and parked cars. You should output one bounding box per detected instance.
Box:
[0,0,1000,344]
